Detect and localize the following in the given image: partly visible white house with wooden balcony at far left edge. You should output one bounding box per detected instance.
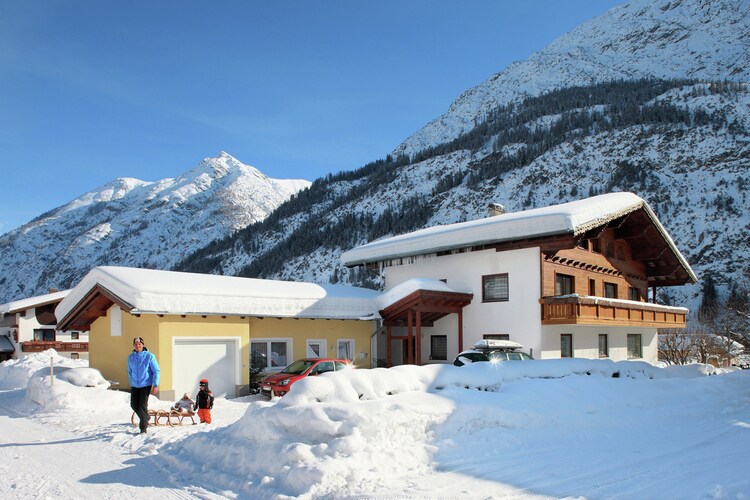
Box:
[0,290,88,361]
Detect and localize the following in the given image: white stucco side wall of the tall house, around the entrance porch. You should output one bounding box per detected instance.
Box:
[379,248,544,363]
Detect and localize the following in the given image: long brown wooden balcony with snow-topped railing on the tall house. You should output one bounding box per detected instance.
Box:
[539,295,689,328]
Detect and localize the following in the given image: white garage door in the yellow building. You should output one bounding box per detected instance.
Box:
[172,339,239,399]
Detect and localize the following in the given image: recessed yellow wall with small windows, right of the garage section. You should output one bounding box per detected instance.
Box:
[250,318,375,368]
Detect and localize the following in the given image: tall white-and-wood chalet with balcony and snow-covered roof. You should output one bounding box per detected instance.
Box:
[342,193,696,366]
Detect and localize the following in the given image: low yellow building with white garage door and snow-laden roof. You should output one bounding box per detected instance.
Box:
[56,267,379,400]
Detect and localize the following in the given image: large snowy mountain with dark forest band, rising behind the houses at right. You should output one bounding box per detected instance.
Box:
[173,0,750,309]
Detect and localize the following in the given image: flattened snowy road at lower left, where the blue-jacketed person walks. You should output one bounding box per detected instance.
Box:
[0,391,229,500]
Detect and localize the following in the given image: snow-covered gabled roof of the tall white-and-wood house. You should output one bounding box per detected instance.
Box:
[341,193,694,284]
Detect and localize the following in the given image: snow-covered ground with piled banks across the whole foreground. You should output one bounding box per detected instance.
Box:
[0,351,750,499]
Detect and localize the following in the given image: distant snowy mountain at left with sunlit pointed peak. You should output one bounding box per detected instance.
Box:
[0,152,310,301]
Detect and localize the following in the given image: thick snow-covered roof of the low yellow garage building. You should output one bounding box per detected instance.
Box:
[55,266,379,319]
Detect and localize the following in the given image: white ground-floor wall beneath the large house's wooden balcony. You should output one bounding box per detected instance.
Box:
[538,325,659,364]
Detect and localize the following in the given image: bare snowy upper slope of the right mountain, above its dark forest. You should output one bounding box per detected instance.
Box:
[394,0,750,155]
